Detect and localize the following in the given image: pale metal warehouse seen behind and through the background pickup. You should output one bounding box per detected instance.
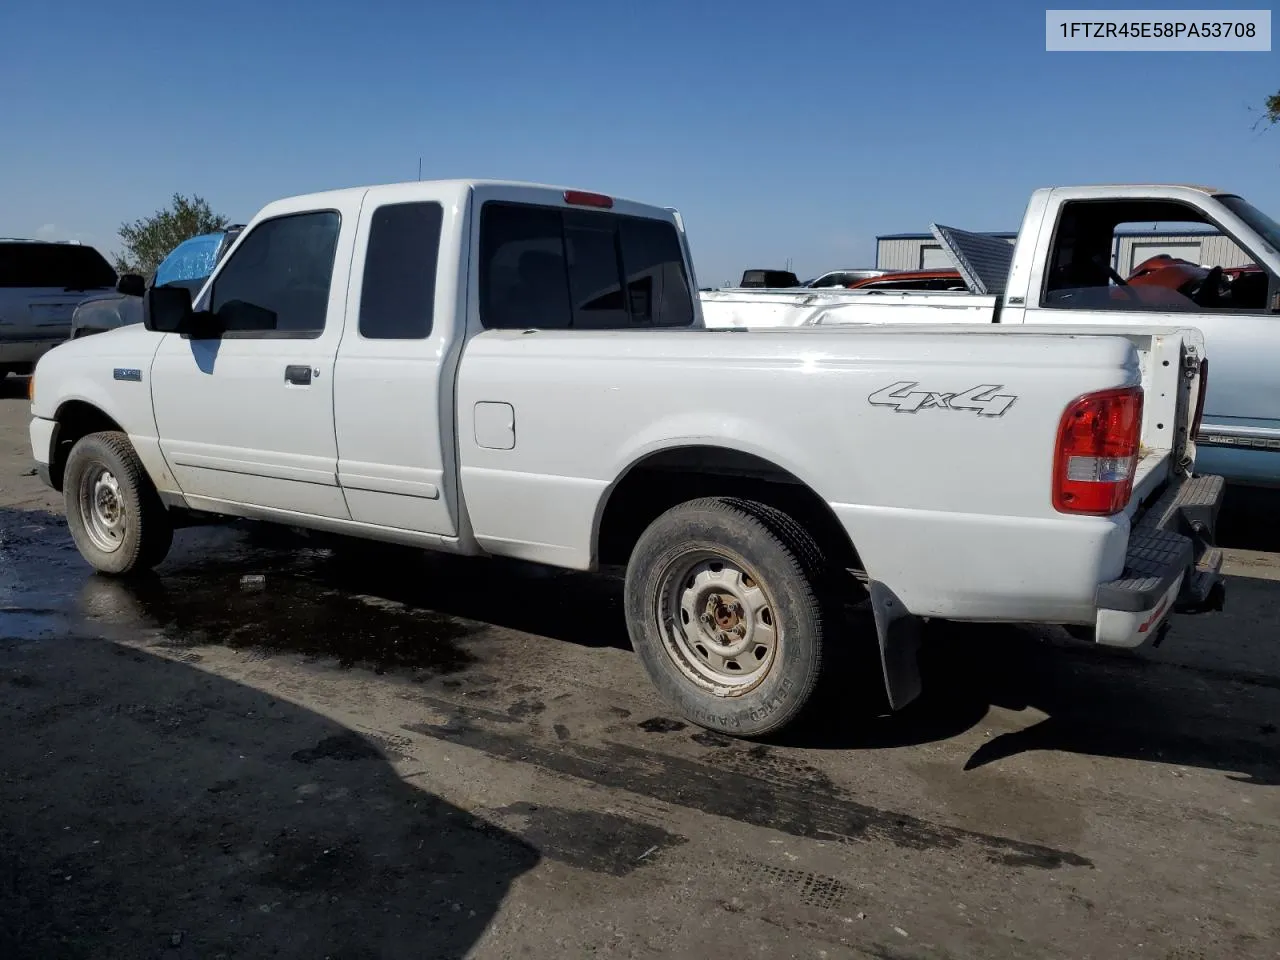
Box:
[876,230,1253,276]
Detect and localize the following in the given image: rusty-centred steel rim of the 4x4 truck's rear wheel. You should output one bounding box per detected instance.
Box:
[658,549,782,696]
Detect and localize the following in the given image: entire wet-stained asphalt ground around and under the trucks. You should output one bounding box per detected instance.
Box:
[0,378,1280,960]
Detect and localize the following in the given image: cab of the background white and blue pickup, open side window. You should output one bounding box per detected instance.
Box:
[1000,184,1280,485]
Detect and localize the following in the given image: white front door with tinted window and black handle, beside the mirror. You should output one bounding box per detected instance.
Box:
[151,191,364,520]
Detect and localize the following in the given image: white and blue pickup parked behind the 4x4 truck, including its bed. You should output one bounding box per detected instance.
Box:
[701,184,1280,486]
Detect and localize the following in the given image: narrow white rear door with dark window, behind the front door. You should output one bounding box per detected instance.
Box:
[334,183,466,536]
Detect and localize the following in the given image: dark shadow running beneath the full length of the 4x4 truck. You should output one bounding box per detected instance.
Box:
[2,511,1280,785]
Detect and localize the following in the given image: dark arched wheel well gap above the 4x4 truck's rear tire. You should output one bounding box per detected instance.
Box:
[596,447,863,570]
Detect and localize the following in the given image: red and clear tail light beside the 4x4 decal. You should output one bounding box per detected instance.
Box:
[1053,387,1142,516]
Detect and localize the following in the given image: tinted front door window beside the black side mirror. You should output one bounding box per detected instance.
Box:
[210,210,342,337]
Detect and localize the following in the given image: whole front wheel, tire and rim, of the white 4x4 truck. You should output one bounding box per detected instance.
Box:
[63,430,173,576]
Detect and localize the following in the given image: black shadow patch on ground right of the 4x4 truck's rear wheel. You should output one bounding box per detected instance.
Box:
[786,611,1280,786]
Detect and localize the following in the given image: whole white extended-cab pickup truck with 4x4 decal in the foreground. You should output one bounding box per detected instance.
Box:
[31,182,1224,736]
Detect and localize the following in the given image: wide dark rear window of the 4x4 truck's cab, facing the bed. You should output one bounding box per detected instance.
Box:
[480,202,694,330]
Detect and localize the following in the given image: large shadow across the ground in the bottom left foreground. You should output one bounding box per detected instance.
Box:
[0,632,539,960]
